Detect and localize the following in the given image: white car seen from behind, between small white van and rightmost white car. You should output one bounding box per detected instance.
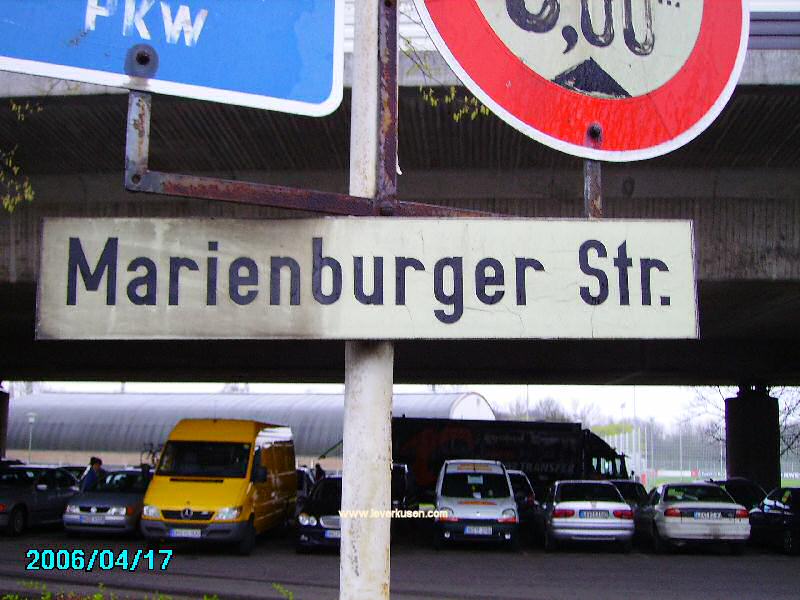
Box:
[540,481,633,552]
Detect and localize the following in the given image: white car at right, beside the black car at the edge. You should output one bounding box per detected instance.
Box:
[636,483,750,554]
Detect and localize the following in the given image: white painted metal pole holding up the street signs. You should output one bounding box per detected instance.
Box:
[339,0,394,600]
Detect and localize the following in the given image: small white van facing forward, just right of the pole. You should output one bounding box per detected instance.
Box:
[434,460,519,548]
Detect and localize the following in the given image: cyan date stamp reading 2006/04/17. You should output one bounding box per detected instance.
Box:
[25,548,172,572]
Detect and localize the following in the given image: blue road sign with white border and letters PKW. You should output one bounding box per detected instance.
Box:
[0,0,344,116]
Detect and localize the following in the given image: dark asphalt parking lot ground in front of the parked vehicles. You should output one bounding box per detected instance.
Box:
[0,529,800,600]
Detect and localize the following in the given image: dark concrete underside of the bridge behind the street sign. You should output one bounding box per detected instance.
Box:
[0,85,800,384]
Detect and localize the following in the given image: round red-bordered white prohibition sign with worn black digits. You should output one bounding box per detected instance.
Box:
[414,0,750,162]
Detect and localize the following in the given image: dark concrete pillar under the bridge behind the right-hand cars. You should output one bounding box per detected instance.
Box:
[725,385,781,492]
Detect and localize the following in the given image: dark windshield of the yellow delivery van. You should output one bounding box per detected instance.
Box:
[157,442,250,477]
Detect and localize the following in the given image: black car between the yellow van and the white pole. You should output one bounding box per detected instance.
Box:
[295,475,342,554]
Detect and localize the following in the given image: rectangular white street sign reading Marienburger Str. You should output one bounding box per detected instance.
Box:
[37,217,698,339]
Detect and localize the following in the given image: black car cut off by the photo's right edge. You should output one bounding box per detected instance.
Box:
[750,487,800,554]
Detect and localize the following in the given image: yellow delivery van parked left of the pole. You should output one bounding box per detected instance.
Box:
[141,419,297,554]
